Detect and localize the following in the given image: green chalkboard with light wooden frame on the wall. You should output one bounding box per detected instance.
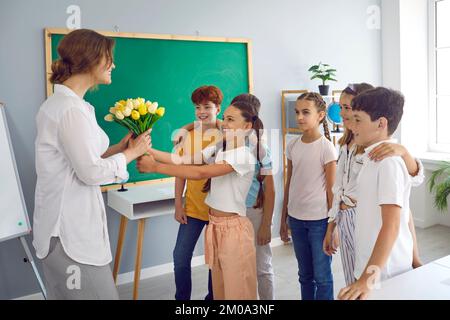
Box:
[46,29,251,186]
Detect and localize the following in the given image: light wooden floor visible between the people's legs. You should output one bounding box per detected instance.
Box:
[119,226,450,300]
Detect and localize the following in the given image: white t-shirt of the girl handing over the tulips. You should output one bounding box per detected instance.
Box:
[203,147,256,216]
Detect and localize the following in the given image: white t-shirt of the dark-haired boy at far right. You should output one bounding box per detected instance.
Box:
[354,141,413,280]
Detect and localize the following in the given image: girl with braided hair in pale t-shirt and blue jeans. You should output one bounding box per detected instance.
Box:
[280,93,337,300]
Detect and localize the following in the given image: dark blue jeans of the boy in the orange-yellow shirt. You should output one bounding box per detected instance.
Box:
[173,217,213,300]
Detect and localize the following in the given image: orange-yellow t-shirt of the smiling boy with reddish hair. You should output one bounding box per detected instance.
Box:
[180,130,219,221]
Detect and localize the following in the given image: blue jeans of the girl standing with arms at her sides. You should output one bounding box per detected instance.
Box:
[289,216,333,300]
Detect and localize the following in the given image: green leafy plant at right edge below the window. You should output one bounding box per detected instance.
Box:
[428,161,450,212]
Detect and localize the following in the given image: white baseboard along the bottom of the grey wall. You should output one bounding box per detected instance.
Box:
[14,237,284,300]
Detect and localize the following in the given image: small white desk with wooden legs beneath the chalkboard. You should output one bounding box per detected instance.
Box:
[108,179,175,300]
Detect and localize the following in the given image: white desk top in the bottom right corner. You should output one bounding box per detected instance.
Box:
[369,256,450,300]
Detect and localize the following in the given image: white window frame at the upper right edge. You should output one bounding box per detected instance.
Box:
[428,0,450,153]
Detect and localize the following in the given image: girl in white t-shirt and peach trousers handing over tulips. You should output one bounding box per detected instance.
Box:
[137,101,263,300]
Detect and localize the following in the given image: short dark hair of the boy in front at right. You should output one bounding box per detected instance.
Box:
[352,87,405,135]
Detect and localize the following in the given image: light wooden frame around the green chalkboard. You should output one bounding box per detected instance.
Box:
[44,28,253,192]
